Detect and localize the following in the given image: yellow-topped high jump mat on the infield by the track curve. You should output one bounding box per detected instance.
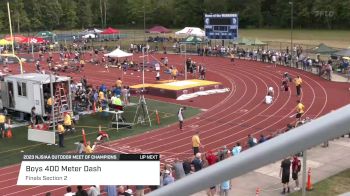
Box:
[130,79,223,99]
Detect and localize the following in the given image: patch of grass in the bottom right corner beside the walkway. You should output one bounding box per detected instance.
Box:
[290,169,350,196]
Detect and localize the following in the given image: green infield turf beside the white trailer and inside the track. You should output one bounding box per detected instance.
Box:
[0,99,200,166]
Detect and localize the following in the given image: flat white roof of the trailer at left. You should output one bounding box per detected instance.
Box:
[6,73,69,84]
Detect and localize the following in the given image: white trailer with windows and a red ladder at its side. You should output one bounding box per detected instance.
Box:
[0,73,72,117]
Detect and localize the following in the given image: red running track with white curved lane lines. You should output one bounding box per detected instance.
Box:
[0,52,350,195]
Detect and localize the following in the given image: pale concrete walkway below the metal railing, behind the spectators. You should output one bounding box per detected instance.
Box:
[193,136,350,196]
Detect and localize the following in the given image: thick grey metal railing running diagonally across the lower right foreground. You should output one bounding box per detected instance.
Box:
[148,104,350,196]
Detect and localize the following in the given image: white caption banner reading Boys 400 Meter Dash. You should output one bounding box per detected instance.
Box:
[17,154,160,185]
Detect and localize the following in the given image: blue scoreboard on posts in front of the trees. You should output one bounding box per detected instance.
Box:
[204,14,238,40]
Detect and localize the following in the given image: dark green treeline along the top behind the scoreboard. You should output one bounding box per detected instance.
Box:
[0,0,350,32]
